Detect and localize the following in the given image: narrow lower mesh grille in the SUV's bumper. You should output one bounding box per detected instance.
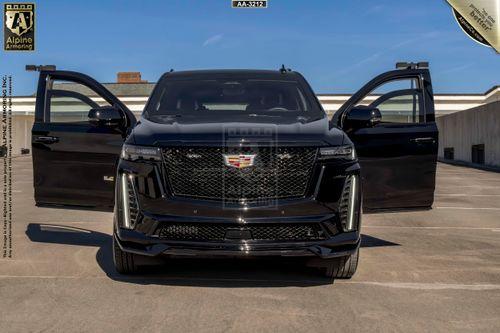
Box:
[157,223,327,241]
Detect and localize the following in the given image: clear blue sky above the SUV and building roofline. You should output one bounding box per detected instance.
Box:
[0,0,500,95]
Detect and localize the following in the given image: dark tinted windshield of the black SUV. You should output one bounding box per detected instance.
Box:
[145,78,324,120]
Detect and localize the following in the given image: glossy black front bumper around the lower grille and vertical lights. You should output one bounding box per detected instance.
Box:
[114,153,361,259]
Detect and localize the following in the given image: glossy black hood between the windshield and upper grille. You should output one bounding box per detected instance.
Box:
[127,116,348,146]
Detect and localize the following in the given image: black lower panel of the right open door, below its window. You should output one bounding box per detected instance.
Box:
[350,123,437,210]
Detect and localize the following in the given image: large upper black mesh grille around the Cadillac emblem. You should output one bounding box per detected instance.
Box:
[163,147,317,201]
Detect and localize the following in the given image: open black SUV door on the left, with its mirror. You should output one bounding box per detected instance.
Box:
[31,66,136,211]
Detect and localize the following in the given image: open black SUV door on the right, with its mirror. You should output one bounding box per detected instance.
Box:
[332,63,438,211]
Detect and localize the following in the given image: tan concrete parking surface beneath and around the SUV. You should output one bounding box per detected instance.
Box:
[0,157,500,332]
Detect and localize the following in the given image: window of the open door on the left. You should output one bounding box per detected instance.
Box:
[46,81,109,124]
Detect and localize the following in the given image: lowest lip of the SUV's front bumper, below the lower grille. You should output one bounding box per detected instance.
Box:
[114,228,360,259]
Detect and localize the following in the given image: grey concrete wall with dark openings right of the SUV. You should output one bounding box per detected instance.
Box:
[436,101,500,167]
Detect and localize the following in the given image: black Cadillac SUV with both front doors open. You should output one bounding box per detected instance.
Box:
[32,63,438,278]
